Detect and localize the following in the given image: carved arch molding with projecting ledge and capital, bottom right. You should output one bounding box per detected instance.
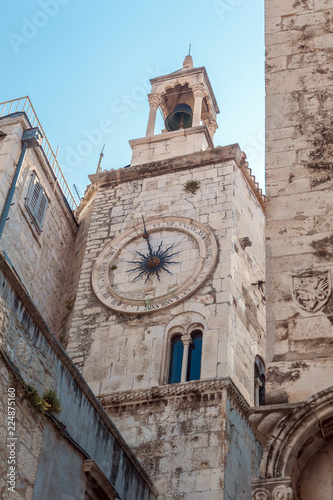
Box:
[249,387,333,490]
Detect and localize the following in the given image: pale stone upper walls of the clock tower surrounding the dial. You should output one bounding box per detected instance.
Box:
[68,146,264,401]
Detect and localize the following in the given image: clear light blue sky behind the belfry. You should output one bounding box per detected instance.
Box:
[0,0,264,199]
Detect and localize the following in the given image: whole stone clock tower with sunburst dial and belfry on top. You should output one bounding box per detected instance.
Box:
[67,56,265,500]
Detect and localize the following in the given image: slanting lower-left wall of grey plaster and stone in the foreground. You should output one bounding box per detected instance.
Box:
[0,257,156,500]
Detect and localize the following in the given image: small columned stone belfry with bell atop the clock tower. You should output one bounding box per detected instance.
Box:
[130,55,219,166]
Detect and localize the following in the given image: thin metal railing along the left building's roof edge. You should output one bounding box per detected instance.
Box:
[0,96,77,210]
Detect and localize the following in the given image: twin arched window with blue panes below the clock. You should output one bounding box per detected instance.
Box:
[168,330,202,384]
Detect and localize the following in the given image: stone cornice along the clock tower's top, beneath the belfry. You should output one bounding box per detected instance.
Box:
[87,144,265,211]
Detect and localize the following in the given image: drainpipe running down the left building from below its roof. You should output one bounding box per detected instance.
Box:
[0,127,43,239]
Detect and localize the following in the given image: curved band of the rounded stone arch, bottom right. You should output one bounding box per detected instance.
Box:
[260,387,333,491]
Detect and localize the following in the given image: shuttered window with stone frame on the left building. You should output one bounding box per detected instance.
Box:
[24,172,49,233]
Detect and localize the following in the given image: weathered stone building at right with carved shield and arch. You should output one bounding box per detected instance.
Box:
[250,0,333,500]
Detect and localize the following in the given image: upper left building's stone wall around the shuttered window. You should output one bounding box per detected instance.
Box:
[0,113,77,334]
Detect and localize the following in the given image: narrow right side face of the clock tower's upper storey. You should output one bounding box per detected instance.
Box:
[228,164,266,404]
